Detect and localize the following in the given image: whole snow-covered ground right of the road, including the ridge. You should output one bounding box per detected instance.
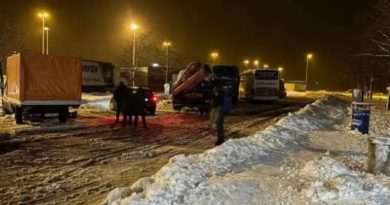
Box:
[105,96,390,205]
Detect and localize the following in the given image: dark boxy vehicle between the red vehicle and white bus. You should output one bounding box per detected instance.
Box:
[212,65,240,103]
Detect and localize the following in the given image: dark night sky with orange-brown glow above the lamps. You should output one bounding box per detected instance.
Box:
[0,0,375,89]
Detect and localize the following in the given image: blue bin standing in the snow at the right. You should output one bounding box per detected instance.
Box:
[351,102,371,134]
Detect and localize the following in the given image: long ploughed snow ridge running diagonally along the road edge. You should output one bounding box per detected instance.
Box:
[105,96,345,205]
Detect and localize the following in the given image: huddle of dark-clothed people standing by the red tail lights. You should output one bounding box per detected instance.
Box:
[114,82,148,129]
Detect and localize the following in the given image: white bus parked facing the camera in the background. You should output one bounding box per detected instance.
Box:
[239,69,286,101]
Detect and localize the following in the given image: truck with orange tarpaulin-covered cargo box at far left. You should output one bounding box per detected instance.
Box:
[2,52,82,124]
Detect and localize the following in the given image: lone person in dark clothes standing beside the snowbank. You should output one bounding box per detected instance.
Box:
[210,87,225,145]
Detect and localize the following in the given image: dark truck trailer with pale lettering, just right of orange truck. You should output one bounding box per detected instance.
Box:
[82,60,114,92]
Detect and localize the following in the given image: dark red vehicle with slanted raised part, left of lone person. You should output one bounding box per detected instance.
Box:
[172,62,212,114]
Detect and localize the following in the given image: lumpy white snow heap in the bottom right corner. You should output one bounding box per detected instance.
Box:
[300,157,390,204]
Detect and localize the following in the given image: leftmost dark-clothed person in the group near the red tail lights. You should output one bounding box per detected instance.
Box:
[114,81,129,123]
